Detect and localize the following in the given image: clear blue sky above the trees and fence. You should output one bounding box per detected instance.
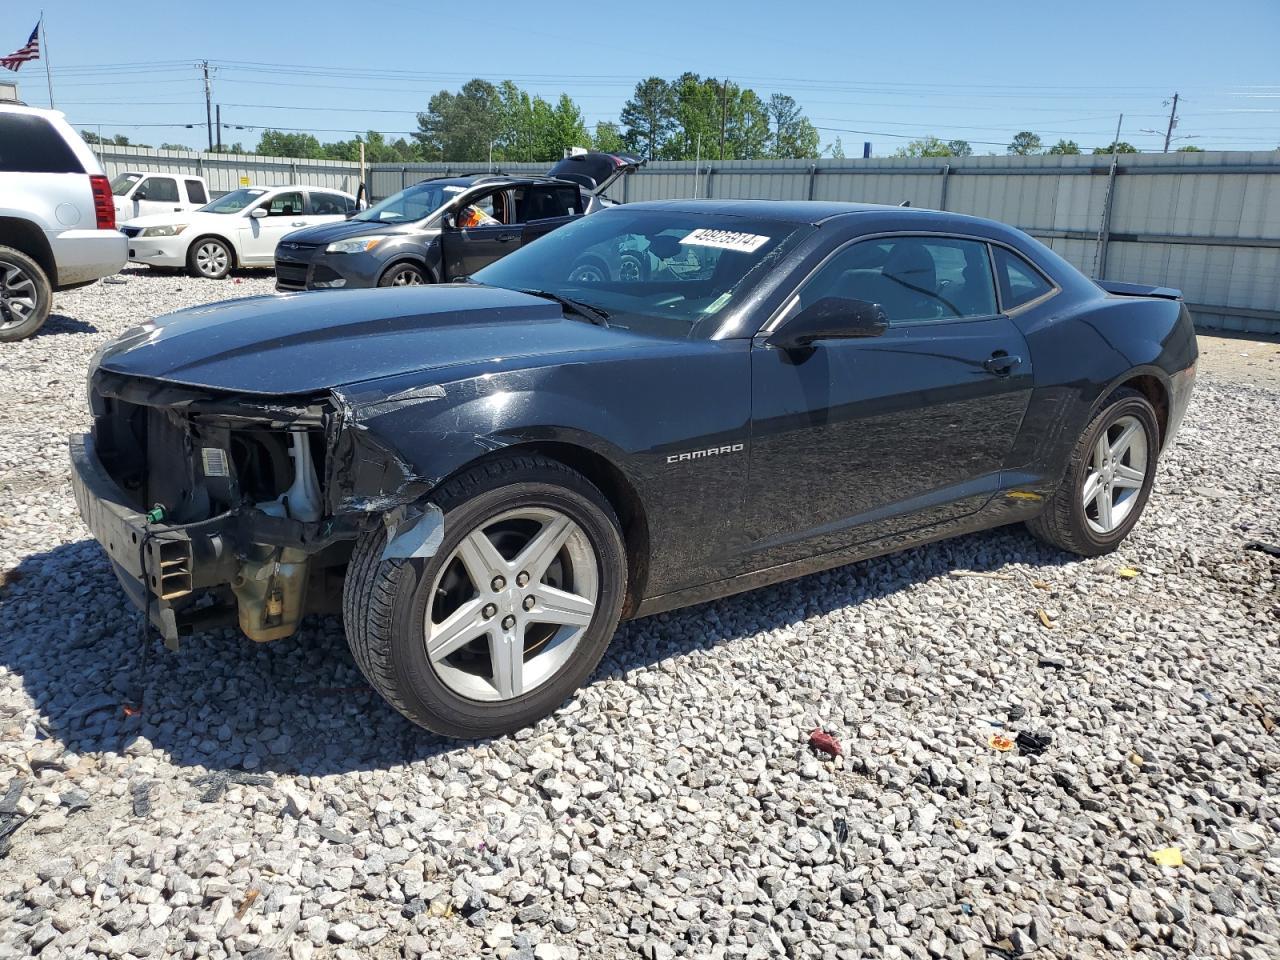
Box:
[0,0,1280,155]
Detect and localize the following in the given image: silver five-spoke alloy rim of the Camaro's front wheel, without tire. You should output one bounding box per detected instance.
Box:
[424,507,600,701]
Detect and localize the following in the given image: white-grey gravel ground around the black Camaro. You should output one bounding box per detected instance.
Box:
[0,271,1280,960]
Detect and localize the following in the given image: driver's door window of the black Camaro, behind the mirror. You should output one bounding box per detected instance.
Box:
[799,237,996,325]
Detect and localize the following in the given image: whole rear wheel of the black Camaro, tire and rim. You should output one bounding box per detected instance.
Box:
[1027,388,1160,557]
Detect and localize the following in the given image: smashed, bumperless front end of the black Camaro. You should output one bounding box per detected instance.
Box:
[70,369,443,648]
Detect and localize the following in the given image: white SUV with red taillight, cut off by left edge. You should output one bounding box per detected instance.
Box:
[0,102,129,340]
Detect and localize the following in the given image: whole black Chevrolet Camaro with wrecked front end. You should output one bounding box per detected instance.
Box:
[72,201,1197,737]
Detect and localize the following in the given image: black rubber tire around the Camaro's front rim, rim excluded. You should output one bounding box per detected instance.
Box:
[343,456,627,739]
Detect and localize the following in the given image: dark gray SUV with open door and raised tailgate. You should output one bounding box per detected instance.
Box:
[275,152,644,291]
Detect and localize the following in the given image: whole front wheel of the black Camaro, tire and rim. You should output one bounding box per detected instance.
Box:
[343,457,627,739]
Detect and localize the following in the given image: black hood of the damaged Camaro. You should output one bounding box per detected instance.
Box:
[97,284,630,396]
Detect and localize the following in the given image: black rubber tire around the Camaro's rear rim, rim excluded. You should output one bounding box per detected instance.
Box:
[1027,388,1160,557]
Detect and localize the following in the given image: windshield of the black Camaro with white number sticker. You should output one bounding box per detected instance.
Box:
[471,206,801,338]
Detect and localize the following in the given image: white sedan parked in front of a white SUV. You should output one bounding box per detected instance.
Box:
[120,186,358,280]
